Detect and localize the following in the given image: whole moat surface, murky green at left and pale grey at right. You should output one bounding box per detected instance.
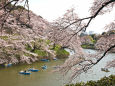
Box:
[0,49,115,86]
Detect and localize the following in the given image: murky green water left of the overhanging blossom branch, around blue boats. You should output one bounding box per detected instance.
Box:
[0,60,64,86]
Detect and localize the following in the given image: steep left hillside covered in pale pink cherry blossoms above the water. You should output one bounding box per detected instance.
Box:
[0,7,69,64]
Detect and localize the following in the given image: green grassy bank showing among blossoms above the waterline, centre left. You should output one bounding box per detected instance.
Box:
[25,39,69,58]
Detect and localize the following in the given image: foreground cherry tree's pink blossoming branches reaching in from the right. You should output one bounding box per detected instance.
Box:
[50,0,115,81]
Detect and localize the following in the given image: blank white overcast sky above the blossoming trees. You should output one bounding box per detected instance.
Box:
[29,0,115,33]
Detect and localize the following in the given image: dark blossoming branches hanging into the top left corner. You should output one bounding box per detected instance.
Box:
[0,0,30,35]
